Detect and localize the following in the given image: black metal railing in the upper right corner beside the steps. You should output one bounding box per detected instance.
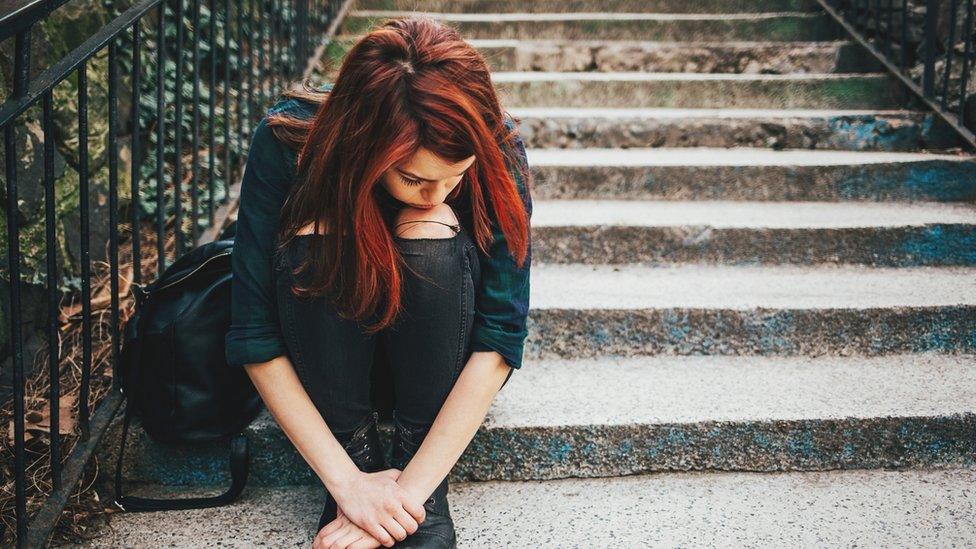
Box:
[817,0,976,149]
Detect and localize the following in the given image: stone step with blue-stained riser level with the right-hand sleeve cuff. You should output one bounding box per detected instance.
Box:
[525,263,976,359]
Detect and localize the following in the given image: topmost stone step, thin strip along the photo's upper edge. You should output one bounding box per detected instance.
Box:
[355,0,820,13]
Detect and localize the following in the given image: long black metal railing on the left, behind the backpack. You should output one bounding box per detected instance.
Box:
[0,0,348,547]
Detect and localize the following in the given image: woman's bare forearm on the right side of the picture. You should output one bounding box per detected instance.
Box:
[397,351,511,503]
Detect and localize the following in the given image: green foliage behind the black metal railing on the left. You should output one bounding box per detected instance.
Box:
[0,0,315,290]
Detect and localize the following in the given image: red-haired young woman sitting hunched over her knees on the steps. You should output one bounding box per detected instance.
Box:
[226,18,532,548]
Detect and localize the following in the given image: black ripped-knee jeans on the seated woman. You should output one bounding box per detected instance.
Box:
[274,218,480,440]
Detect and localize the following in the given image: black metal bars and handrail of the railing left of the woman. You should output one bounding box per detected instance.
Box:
[0,0,349,547]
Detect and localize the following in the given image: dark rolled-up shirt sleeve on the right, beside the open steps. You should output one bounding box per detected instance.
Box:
[471,113,532,374]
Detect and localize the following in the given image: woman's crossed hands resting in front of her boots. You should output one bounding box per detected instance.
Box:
[326,468,427,547]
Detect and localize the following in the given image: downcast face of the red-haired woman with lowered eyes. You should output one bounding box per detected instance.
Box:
[382,147,475,208]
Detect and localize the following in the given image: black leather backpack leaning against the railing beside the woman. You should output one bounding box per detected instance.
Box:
[114,228,263,511]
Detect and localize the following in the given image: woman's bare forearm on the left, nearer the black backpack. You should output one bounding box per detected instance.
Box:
[244,355,360,493]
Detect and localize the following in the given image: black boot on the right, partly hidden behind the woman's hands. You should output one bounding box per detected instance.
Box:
[391,412,457,549]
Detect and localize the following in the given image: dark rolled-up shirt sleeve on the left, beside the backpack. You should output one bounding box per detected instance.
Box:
[224,116,294,366]
